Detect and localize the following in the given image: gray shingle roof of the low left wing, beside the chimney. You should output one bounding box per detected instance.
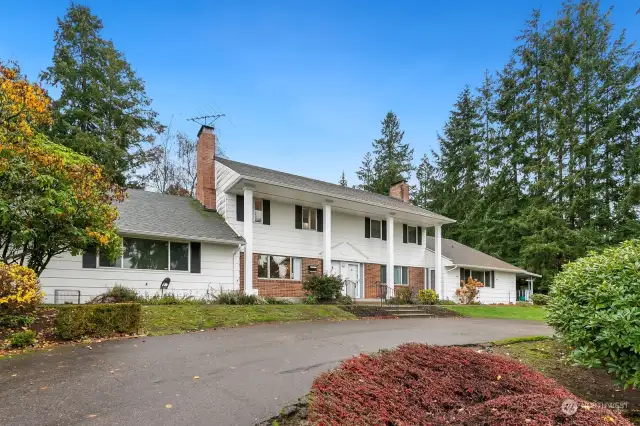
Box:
[116,189,244,244]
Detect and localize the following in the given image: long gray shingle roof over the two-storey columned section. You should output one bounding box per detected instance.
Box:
[216,157,455,223]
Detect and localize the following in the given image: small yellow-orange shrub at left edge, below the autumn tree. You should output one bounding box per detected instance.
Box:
[0,263,44,315]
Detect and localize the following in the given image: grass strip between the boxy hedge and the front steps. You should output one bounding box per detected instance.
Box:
[142,305,356,336]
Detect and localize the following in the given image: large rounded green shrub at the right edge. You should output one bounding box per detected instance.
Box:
[547,240,640,387]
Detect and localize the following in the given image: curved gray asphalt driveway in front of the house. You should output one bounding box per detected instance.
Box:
[0,318,551,426]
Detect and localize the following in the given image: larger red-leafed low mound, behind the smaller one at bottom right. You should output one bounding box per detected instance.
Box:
[309,344,628,426]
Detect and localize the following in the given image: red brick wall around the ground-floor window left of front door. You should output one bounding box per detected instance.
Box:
[240,252,322,297]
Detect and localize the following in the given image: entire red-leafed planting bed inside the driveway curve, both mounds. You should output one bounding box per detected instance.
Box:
[262,342,631,426]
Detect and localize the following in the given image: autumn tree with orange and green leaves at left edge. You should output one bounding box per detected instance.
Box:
[0,61,123,275]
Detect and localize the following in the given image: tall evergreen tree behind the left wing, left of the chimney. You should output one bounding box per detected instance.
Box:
[41,4,162,184]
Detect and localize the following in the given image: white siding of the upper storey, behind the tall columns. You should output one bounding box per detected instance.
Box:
[226,195,435,268]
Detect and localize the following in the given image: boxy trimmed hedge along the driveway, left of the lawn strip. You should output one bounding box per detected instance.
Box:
[55,303,141,340]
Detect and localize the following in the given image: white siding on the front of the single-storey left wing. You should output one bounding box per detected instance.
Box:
[40,243,238,303]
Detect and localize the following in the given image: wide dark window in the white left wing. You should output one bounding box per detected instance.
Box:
[98,237,190,272]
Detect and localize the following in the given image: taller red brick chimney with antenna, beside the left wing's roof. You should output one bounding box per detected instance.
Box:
[196,126,216,210]
